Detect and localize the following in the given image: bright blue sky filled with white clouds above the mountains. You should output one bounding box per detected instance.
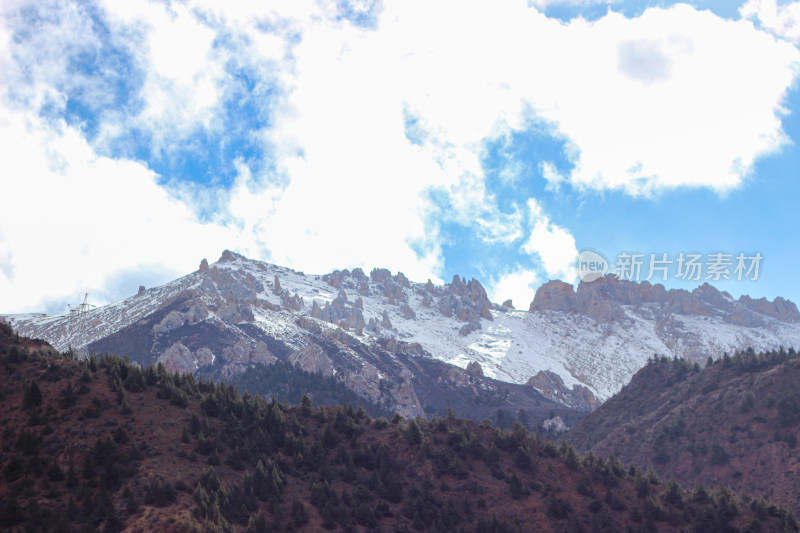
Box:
[0,0,800,313]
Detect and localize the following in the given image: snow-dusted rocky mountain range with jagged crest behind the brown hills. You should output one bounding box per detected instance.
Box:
[1,251,800,414]
